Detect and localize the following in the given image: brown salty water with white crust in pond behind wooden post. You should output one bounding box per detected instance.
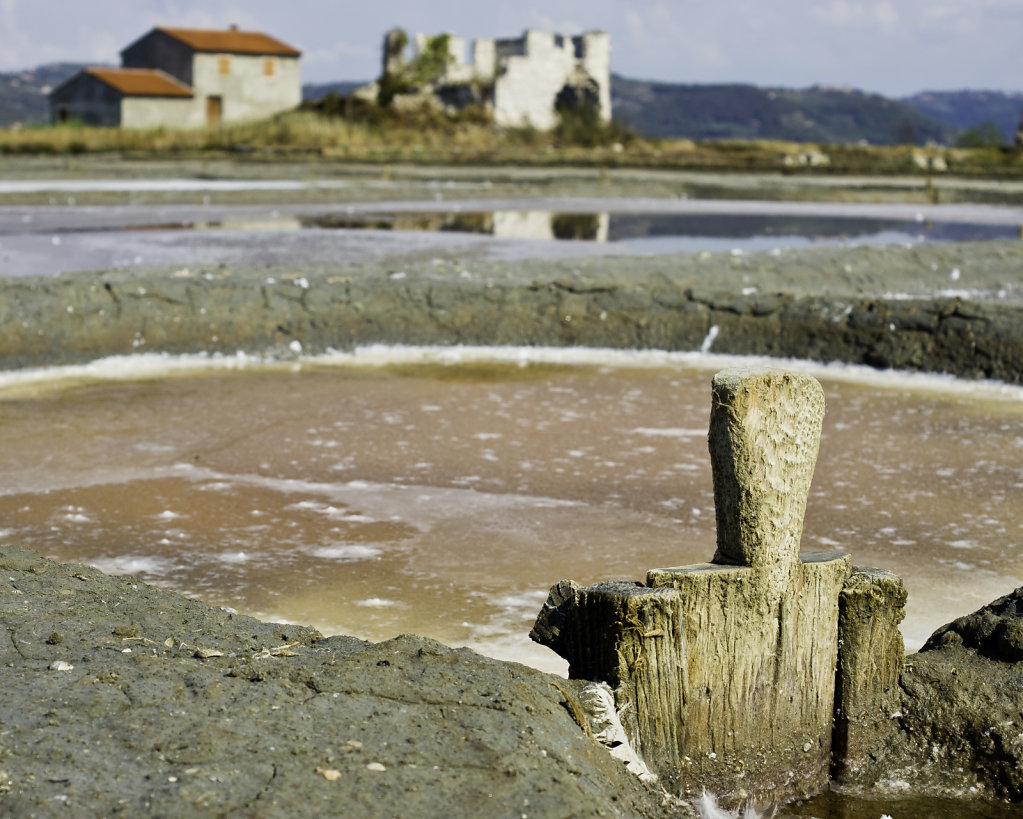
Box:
[0,351,1023,671]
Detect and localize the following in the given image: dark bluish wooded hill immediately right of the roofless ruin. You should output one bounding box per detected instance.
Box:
[611,76,958,145]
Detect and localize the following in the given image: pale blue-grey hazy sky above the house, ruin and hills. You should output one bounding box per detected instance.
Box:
[0,0,1023,96]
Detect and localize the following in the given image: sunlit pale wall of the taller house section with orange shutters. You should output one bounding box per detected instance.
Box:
[191,53,302,122]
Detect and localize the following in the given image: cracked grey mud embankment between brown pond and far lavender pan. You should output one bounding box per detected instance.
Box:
[0,242,1023,383]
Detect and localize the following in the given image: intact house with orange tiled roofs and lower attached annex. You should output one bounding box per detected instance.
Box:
[50,27,302,128]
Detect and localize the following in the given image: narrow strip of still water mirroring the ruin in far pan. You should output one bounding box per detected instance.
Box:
[28,202,1020,249]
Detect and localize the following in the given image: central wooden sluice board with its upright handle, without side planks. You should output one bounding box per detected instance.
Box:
[647,370,850,799]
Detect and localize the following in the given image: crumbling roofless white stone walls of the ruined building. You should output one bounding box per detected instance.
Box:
[384,31,611,130]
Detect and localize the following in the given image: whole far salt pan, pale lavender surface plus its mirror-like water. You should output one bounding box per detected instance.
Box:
[0,194,1023,276]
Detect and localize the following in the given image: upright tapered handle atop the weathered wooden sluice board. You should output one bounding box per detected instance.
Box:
[709,367,825,571]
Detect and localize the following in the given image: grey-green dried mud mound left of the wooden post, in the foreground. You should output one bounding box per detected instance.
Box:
[0,547,691,819]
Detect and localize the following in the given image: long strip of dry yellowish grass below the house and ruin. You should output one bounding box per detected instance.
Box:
[0,111,1023,178]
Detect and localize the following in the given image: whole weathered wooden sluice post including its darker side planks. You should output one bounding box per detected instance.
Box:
[531,369,904,804]
